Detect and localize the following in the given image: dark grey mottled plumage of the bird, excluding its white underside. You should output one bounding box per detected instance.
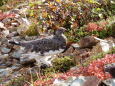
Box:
[9,28,66,55]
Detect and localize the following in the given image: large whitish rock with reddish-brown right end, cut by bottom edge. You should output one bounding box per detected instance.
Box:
[53,76,100,86]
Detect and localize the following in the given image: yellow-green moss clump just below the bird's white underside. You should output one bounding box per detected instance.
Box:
[43,56,75,74]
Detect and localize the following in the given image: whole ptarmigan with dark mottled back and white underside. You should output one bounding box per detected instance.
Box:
[9,27,67,66]
